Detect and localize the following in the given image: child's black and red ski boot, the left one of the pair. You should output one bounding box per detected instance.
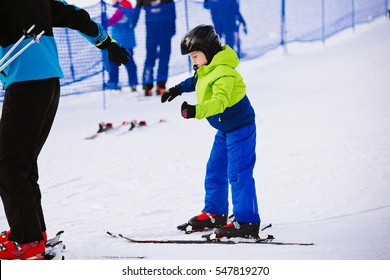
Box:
[177,211,227,233]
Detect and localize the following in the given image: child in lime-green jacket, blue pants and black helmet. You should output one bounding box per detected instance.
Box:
[161,25,260,238]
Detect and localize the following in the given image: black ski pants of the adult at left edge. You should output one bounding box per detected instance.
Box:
[0,78,60,243]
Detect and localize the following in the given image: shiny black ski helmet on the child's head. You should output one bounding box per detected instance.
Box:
[180,24,222,62]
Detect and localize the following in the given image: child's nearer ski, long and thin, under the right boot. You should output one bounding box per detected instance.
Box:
[106,231,314,246]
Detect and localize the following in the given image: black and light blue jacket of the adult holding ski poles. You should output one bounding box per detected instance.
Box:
[0,0,107,89]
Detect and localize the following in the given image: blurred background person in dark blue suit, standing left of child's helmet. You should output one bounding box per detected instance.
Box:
[134,0,176,96]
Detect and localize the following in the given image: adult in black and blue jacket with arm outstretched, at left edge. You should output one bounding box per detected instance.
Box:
[0,0,129,260]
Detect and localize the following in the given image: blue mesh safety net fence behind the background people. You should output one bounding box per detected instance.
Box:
[0,0,389,102]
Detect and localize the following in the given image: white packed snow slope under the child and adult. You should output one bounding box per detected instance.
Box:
[0,18,390,260]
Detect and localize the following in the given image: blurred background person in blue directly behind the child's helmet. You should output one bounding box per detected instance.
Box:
[204,0,248,57]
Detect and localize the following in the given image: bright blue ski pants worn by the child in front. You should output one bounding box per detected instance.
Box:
[204,124,260,223]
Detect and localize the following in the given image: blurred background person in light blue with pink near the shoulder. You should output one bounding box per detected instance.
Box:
[107,0,138,92]
